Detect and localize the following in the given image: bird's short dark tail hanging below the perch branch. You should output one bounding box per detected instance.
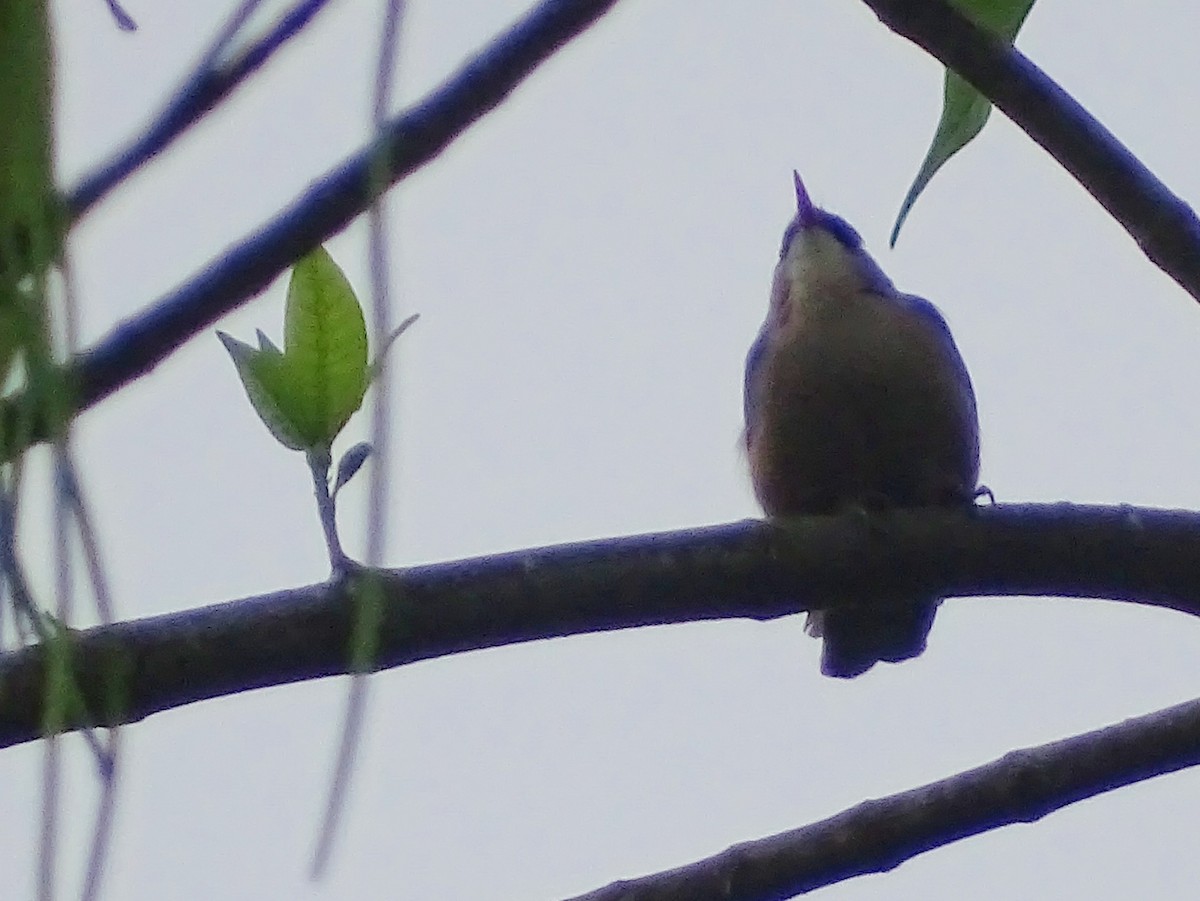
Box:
[804,599,940,679]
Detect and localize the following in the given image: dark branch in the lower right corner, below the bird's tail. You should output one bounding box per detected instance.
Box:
[575,701,1200,901]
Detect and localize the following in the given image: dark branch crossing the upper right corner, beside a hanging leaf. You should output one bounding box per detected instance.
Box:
[864,0,1200,300]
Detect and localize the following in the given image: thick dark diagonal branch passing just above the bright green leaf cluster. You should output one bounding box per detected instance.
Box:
[0,0,617,458]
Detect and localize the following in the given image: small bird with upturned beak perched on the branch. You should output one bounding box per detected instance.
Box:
[744,172,979,678]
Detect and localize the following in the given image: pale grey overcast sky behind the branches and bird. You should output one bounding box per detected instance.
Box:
[0,0,1200,901]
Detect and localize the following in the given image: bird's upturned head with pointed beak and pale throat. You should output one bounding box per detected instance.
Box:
[776,172,895,314]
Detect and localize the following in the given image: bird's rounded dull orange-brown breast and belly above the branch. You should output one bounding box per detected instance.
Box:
[746,295,978,515]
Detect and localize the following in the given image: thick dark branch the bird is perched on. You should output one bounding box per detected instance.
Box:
[0,505,1200,747]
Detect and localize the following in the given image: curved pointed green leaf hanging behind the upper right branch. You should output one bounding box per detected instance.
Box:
[890,0,1033,246]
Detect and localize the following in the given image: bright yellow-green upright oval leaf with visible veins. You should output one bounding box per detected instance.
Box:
[283,247,367,448]
